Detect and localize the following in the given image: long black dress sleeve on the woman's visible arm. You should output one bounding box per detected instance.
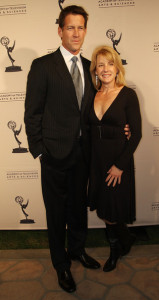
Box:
[115,89,142,170]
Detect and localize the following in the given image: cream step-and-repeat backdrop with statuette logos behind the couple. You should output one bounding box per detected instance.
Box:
[0,0,159,229]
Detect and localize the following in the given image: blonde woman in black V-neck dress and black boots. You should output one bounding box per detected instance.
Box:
[88,46,141,272]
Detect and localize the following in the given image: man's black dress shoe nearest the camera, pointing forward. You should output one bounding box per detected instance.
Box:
[57,270,76,293]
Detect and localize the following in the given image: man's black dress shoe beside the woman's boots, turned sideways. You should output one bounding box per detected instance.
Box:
[69,253,100,269]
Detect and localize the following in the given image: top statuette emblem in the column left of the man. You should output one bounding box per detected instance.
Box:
[0,36,22,72]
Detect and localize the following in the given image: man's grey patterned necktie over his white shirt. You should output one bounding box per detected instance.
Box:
[70,56,83,108]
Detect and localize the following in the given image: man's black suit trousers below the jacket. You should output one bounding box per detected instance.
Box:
[41,141,88,271]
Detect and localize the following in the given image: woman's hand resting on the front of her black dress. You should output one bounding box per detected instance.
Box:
[105,165,123,187]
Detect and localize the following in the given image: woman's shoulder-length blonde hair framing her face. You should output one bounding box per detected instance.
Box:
[90,46,126,90]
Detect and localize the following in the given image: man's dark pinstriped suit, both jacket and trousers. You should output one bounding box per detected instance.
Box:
[25,49,94,270]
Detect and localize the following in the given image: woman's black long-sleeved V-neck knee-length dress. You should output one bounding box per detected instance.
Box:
[88,86,141,223]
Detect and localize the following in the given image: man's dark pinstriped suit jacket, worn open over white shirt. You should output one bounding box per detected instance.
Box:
[24,49,94,159]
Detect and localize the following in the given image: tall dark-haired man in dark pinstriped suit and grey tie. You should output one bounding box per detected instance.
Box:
[24,5,100,292]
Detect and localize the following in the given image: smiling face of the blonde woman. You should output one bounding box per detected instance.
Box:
[96,54,118,85]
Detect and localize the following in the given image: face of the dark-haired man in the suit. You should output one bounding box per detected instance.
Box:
[58,14,87,55]
